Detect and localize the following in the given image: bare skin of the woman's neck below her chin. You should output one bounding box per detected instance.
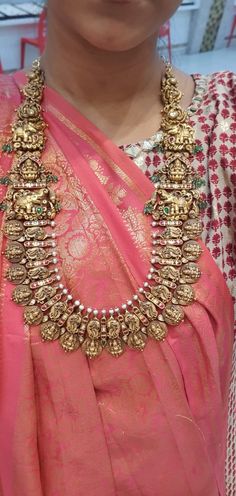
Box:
[41,12,192,144]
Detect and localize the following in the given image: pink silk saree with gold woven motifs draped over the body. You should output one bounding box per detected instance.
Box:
[0,74,233,496]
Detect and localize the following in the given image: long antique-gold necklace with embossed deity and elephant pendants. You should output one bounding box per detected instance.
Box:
[1,61,205,358]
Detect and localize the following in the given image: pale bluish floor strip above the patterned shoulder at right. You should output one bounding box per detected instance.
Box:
[173,43,236,74]
